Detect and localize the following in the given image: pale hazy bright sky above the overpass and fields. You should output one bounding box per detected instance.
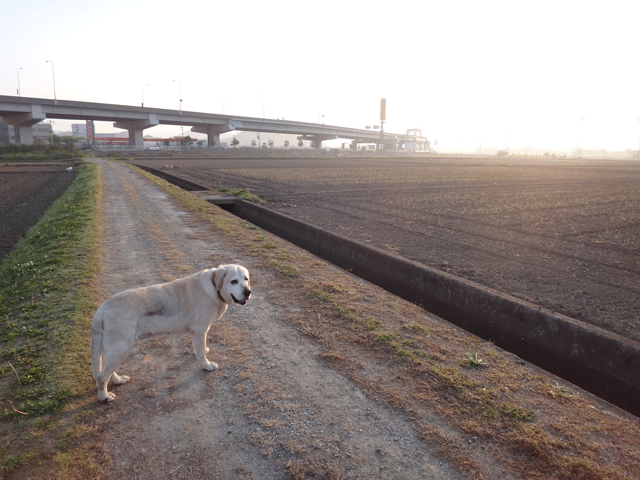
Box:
[0,0,640,151]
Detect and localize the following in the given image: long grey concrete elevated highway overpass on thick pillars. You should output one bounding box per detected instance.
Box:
[0,95,428,150]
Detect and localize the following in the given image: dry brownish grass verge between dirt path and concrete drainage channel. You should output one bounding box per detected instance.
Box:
[127,161,640,480]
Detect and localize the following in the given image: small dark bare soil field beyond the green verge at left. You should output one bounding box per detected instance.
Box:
[0,161,76,262]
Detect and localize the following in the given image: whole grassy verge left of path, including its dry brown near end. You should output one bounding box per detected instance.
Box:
[0,162,105,478]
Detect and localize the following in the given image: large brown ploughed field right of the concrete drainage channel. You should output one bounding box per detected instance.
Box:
[130,158,640,340]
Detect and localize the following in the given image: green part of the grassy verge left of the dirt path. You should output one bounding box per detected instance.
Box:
[0,162,99,420]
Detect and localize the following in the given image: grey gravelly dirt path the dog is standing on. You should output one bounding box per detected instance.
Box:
[96,159,464,479]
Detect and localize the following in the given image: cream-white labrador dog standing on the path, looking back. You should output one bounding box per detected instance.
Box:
[91,265,251,402]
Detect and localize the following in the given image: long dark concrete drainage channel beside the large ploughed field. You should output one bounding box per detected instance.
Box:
[141,167,640,416]
